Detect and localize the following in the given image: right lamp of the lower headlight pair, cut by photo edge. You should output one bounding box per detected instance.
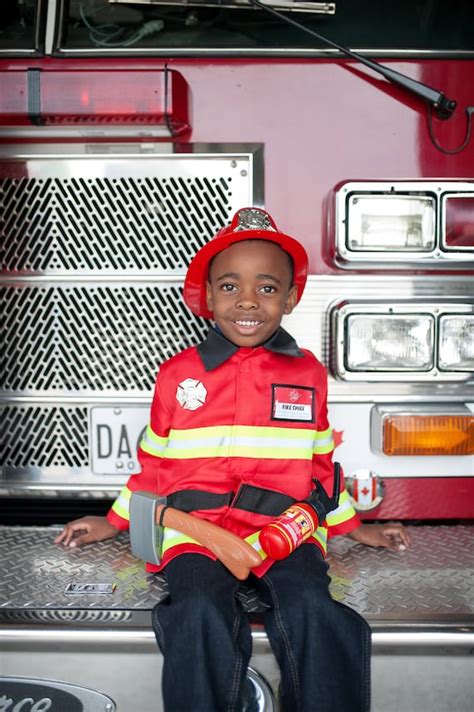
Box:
[439,315,474,371]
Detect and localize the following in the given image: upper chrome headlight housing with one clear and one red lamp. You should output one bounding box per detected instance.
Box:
[329,180,474,269]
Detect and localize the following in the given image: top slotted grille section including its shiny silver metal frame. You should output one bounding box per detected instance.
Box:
[0,147,252,274]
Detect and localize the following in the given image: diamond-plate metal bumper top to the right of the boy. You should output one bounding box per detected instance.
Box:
[330,525,474,622]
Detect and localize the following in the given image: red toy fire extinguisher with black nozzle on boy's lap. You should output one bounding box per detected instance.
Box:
[258,462,341,560]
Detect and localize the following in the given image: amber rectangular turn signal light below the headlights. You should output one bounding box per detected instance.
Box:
[383,414,474,455]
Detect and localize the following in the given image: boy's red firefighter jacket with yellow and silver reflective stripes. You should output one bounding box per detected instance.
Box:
[107,329,360,575]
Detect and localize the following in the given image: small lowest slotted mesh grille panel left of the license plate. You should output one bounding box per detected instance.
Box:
[0,405,89,467]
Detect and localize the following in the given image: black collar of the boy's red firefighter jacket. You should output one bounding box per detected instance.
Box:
[197,326,304,371]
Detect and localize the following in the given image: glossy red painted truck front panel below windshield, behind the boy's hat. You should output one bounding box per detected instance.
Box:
[0,58,474,274]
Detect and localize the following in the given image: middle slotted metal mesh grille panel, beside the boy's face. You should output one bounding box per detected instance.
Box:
[0,285,207,393]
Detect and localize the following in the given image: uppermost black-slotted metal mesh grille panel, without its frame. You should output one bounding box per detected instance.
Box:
[0,176,233,273]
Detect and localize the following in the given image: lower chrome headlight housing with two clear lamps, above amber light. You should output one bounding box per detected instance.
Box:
[332,299,474,381]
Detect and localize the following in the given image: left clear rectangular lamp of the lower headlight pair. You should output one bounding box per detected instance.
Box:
[346,314,434,371]
